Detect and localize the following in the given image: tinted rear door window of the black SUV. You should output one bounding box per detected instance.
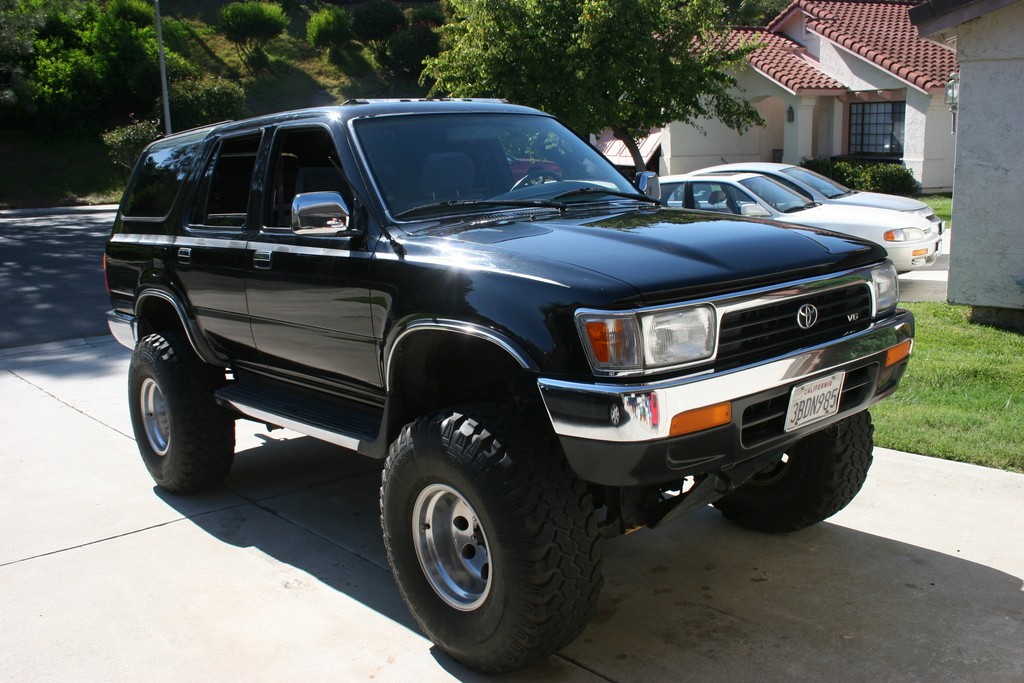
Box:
[189,133,261,227]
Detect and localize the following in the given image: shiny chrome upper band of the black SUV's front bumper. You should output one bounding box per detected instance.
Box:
[538,311,913,442]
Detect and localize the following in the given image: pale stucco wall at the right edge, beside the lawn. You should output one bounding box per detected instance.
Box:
[947,2,1024,310]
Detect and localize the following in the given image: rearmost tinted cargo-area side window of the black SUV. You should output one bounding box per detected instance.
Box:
[122,133,206,218]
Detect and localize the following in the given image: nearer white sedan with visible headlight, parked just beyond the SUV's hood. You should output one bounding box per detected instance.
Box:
[660,173,942,272]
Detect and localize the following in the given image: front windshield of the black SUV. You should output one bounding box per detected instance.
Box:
[353,113,637,219]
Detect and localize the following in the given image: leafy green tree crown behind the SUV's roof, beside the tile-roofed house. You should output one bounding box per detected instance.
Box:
[423,0,762,170]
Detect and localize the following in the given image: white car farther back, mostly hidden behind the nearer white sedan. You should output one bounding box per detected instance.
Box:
[690,162,944,234]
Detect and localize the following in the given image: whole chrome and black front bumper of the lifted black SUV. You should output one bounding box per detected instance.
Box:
[538,310,913,485]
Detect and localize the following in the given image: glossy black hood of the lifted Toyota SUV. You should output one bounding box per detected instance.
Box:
[407,209,885,303]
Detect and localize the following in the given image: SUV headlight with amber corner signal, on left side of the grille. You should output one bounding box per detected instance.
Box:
[577,305,717,375]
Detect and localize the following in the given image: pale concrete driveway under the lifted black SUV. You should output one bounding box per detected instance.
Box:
[0,337,1024,683]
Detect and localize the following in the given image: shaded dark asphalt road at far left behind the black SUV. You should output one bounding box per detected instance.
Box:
[0,207,114,348]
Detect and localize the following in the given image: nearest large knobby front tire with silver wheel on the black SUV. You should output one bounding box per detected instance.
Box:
[381,403,602,673]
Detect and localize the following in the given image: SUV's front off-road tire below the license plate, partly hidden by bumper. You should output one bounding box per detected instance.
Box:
[715,411,873,533]
